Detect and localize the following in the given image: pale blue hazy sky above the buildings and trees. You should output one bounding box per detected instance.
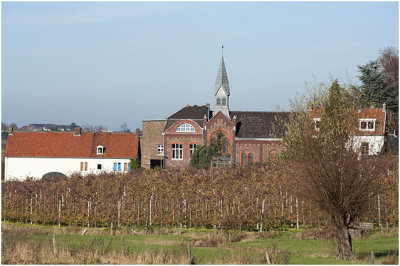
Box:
[1,2,399,131]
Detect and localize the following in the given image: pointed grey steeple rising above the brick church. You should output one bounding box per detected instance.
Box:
[214,52,230,118]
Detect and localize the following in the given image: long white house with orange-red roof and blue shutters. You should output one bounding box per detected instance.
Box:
[5,128,139,180]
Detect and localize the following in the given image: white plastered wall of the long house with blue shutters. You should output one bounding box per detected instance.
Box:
[5,157,130,180]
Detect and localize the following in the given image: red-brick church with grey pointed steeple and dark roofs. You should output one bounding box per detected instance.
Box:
[141,56,289,168]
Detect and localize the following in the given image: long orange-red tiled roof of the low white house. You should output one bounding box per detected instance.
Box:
[5,132,139,158]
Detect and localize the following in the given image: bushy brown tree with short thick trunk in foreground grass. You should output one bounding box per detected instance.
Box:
[284,81,377,260]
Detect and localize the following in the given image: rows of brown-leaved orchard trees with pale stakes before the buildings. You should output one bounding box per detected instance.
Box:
[2,159,398,232]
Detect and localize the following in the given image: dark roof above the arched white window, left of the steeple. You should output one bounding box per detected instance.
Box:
[165,105,208,130]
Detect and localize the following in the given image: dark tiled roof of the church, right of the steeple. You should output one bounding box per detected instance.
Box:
[230,111,289,138]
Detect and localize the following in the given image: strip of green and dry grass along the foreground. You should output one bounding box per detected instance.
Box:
[2,223,399,264]
